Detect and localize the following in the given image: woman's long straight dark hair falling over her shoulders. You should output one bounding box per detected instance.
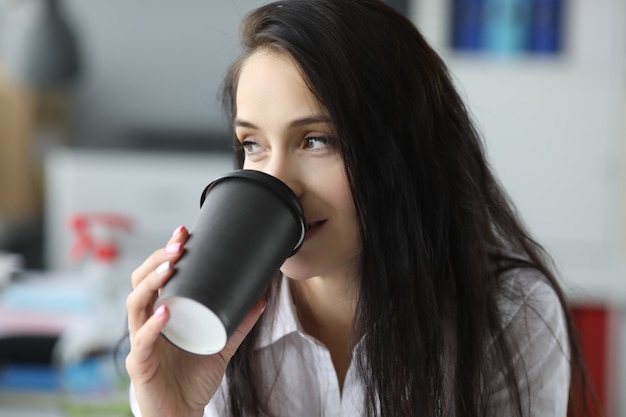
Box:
[224,0,586,417]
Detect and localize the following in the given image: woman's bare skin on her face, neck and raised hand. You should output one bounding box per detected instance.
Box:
[126,51,360,417]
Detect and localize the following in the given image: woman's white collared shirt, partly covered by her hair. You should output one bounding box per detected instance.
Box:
[131,269,570,417]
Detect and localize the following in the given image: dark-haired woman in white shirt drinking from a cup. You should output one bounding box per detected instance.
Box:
[127,0,585,417]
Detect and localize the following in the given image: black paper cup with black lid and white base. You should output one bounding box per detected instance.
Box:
[154,170,306,355]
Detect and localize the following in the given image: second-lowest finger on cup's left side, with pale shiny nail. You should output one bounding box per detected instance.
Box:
[126,261,174,334]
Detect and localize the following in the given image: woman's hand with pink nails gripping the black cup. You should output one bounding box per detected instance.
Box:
[126,227,265,417]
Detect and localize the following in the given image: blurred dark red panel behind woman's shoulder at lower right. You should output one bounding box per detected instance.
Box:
[572,306,610,417]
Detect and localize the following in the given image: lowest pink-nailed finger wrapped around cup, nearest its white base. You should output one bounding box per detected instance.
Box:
[126,305,170,377]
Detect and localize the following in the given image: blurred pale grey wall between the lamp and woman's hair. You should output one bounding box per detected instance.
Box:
[64,0,262,144]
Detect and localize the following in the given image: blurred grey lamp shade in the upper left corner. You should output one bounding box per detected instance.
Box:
[0,0,80,88]
